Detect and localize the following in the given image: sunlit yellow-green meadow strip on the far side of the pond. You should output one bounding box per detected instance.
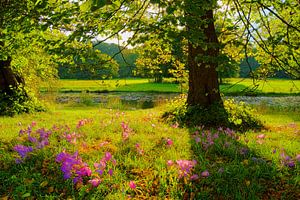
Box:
[41,78,300,95]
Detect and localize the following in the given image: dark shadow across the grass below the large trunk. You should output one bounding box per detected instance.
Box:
[185,129,300,199]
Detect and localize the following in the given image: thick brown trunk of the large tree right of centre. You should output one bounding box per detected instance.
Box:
[187,10,222,107]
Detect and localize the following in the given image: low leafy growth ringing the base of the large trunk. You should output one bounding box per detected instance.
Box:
[162,96,263,131]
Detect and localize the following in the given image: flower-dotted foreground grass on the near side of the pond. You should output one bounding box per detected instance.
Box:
[0,102,300,199]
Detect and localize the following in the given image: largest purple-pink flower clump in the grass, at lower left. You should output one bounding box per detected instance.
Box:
[56,151,92,183]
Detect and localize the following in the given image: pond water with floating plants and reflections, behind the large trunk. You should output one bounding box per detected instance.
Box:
[47,92,300,109]
